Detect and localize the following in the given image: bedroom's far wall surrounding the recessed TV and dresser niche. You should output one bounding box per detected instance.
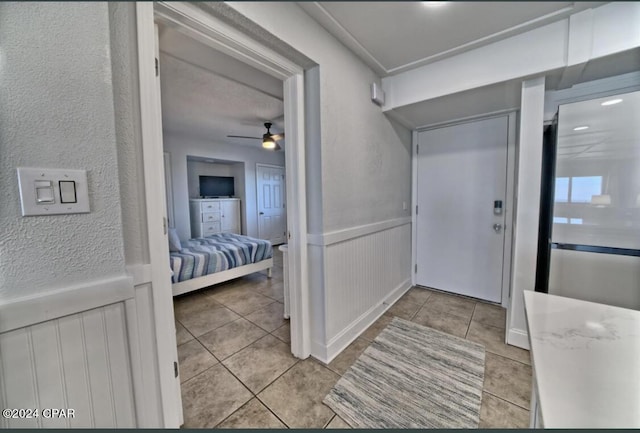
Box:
[164,132,284,240]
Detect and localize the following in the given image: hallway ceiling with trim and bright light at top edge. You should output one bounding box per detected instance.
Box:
[298,1,605,77]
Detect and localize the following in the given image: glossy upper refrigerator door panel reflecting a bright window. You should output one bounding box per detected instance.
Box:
[552,92,640,249]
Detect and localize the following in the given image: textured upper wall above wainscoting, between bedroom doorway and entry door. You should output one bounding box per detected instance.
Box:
[230,2,411,232]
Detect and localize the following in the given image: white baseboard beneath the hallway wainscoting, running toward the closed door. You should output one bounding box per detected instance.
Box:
[311,279,411,364]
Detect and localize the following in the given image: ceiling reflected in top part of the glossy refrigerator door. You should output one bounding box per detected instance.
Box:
[558,92,640,160]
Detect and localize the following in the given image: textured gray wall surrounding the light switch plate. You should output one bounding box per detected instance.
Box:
[0,2,124,302]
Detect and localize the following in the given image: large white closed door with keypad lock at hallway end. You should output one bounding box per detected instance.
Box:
[416,116,510,302]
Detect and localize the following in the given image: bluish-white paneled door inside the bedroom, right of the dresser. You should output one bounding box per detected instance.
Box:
[256,164,287,245]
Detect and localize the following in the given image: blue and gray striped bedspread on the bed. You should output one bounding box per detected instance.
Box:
[170,233,273,283]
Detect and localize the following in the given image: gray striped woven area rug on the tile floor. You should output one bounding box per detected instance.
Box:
[324,317,484,428]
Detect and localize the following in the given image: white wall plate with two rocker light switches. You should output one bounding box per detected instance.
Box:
[18,167,89,216]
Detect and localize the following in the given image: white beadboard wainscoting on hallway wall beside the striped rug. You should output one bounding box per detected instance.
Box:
[324,223,411,345]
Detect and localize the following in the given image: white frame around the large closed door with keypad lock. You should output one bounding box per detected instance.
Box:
[411,110,517,308]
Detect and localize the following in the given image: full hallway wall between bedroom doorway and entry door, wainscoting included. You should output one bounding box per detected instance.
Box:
[228,2,411,361]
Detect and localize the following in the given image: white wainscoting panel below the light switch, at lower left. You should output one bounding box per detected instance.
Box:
[0,302,136,428]
